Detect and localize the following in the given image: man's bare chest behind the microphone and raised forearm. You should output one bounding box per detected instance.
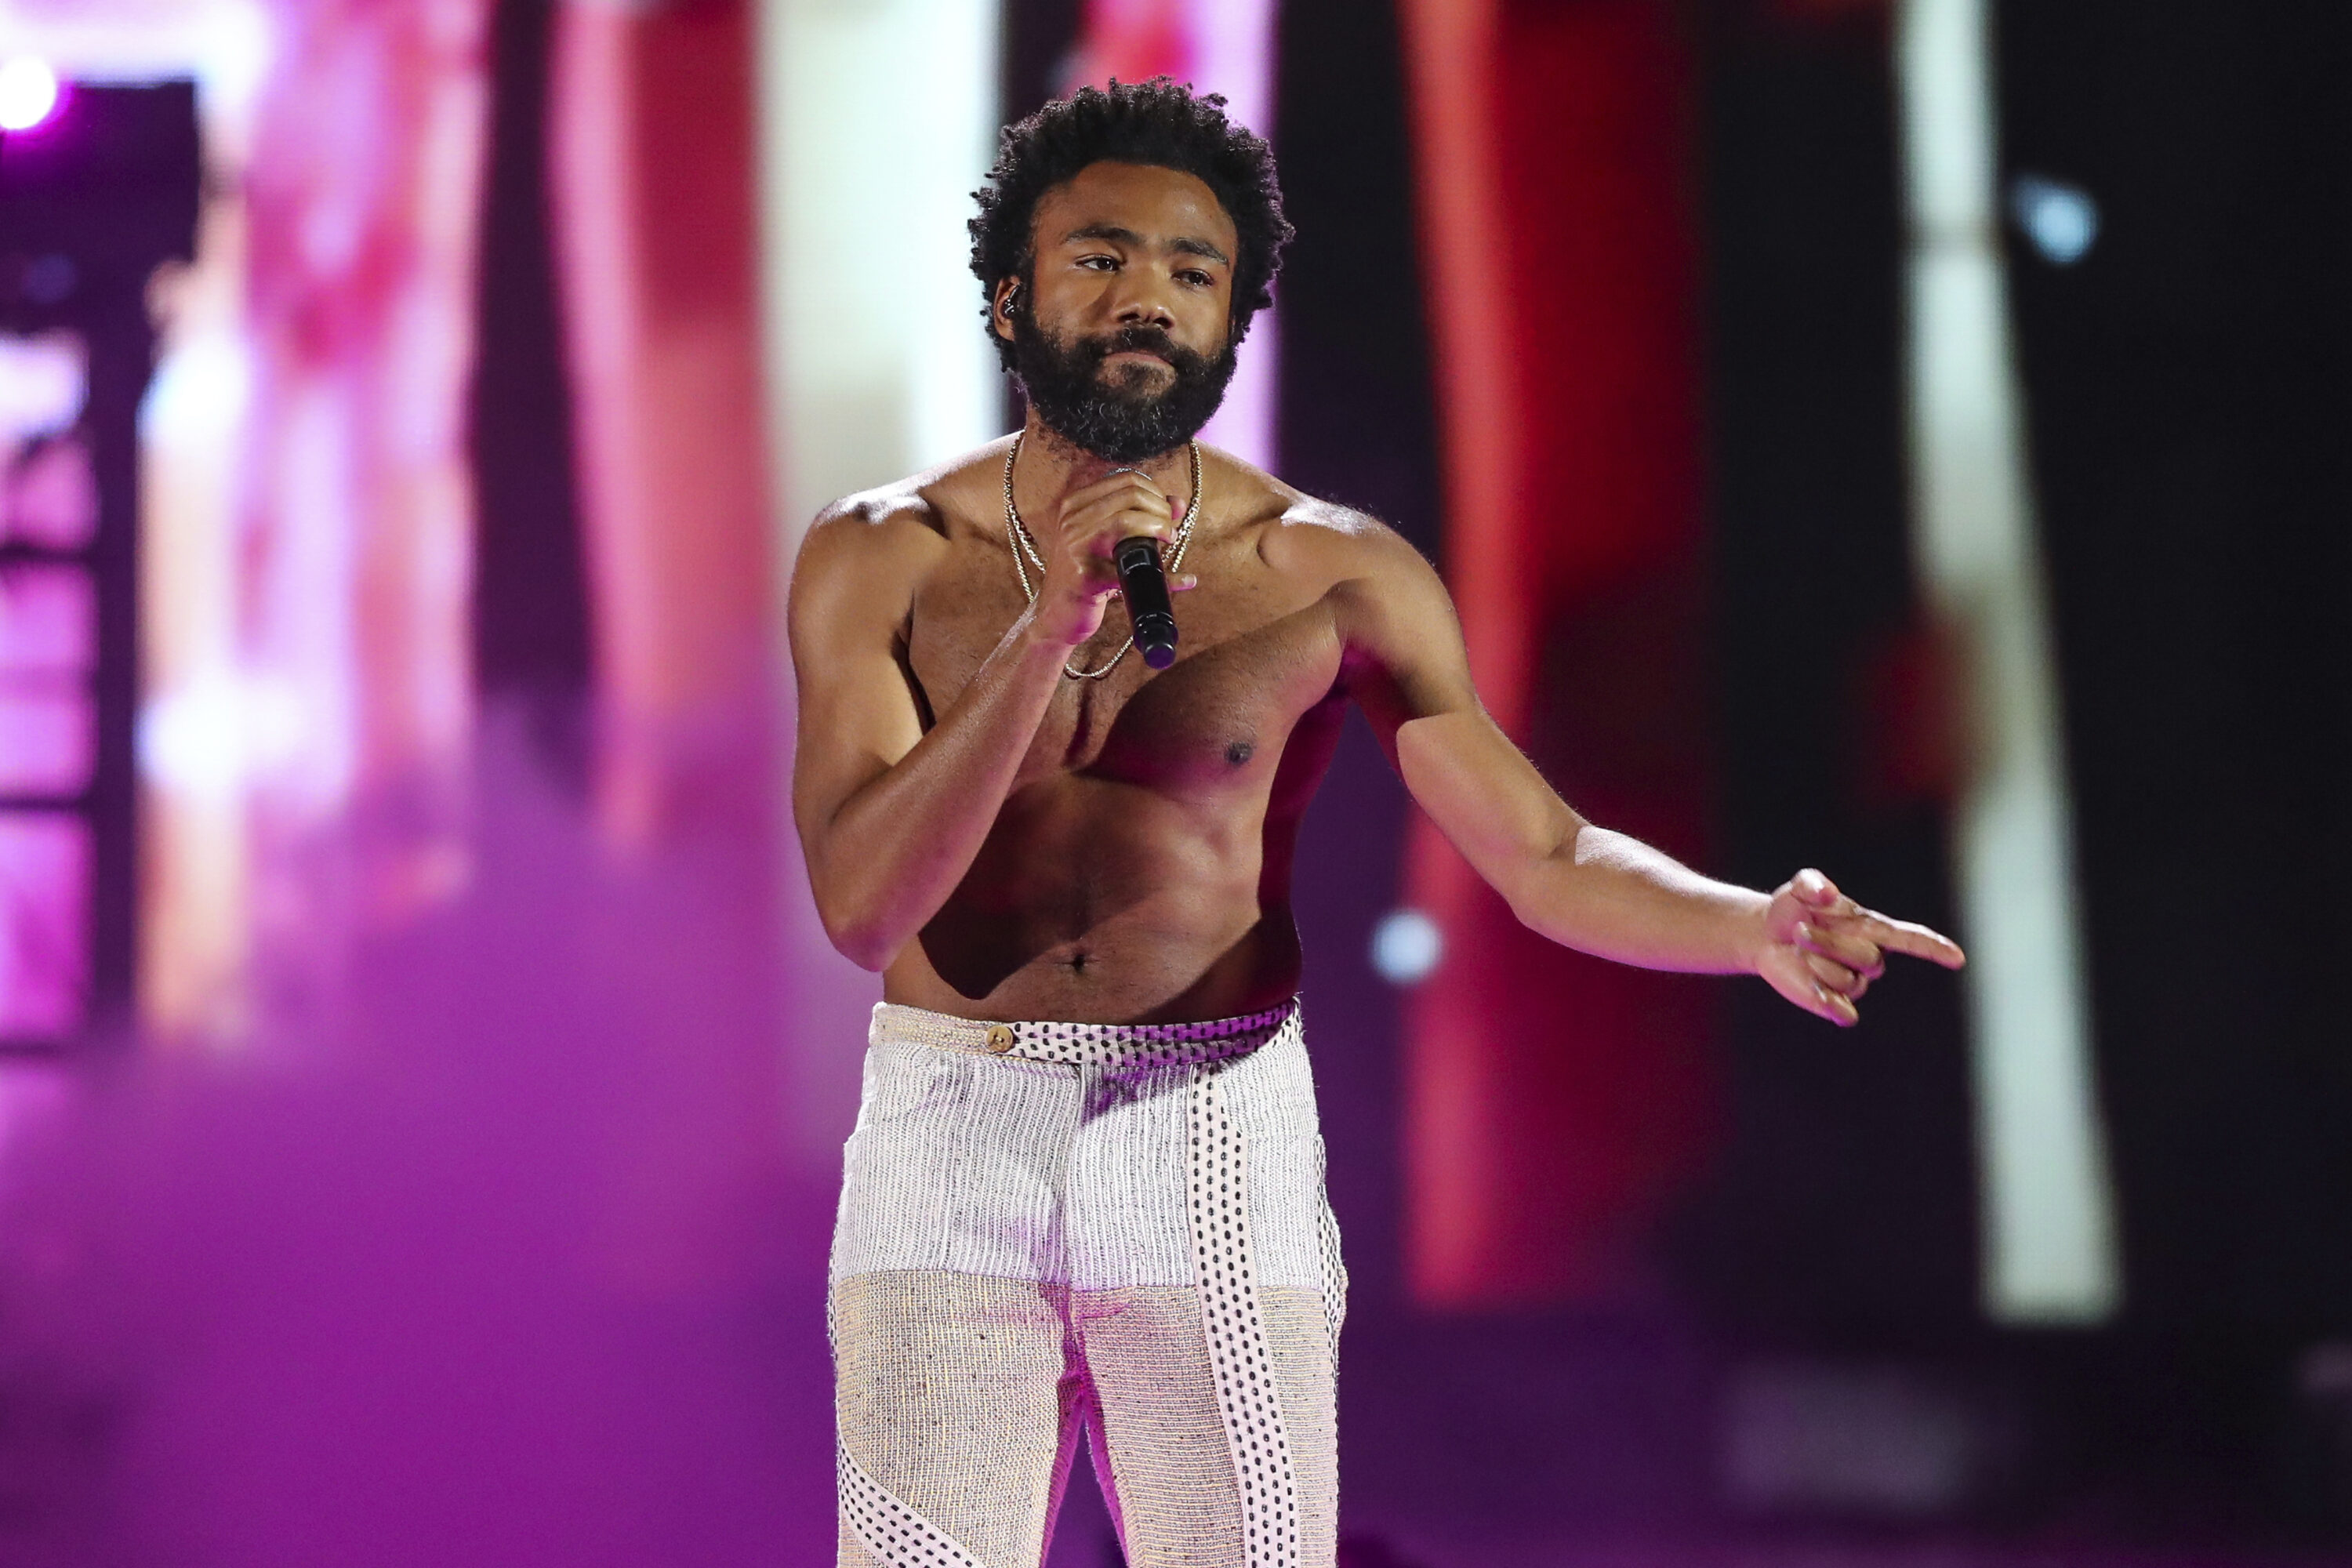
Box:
[908,543,1341,789]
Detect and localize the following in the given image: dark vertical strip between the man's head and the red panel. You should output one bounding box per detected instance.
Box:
[1275,0,1439,1316]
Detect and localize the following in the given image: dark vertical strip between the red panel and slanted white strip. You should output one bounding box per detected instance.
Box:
[1682,0,1976,1347]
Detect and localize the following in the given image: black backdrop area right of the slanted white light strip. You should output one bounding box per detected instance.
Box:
[1999,0,2352,1516]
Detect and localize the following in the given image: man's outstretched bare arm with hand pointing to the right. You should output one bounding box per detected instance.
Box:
[1334,527,1964,1025]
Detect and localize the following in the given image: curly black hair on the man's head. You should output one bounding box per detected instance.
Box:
[967,75,1294,369]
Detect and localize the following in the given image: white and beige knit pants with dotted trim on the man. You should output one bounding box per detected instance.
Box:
[830,1004,1345,1568]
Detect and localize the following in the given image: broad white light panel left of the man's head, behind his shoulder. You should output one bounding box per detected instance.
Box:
[757,0,1004,1161]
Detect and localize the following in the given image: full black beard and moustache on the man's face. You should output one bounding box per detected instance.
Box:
[1014,315,1235,463]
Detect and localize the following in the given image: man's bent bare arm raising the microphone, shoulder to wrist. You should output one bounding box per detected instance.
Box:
[790,503,1068,968]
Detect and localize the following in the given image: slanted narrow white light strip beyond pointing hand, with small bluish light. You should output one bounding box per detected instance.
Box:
[1896,0,2122,1323]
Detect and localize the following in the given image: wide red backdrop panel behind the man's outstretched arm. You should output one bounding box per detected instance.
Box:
[1402,0,1717,1307]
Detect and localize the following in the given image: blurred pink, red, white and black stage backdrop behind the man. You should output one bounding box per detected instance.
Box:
[0,0,2352,1568]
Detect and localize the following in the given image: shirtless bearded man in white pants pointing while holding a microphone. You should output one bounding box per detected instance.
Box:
[793,80,1962,1568]
